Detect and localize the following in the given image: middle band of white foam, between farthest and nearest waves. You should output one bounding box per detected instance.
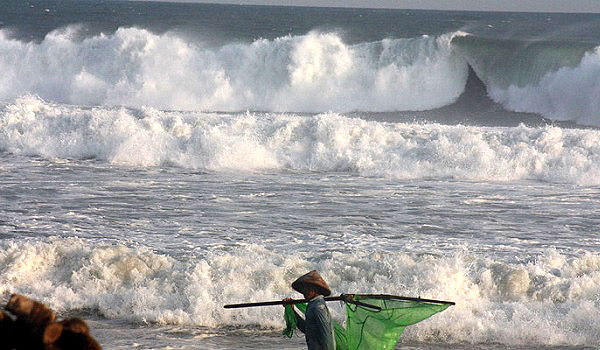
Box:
[0,97,600,185]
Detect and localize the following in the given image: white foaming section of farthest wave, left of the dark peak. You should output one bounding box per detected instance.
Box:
[0,27,467,112]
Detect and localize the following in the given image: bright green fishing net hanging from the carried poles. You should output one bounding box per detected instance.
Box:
[284,295,450,350]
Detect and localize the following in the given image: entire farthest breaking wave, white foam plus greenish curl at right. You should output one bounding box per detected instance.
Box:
[0,26,600,126]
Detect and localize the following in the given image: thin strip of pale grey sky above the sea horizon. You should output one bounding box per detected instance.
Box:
[135,0,600,13]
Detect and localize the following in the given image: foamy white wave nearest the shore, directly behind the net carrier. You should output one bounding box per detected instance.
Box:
[0,239,600,346]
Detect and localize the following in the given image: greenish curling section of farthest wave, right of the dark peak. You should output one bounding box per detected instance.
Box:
[452,35,600,126]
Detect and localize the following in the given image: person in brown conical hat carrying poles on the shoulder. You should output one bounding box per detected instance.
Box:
[284,270,335,350]
